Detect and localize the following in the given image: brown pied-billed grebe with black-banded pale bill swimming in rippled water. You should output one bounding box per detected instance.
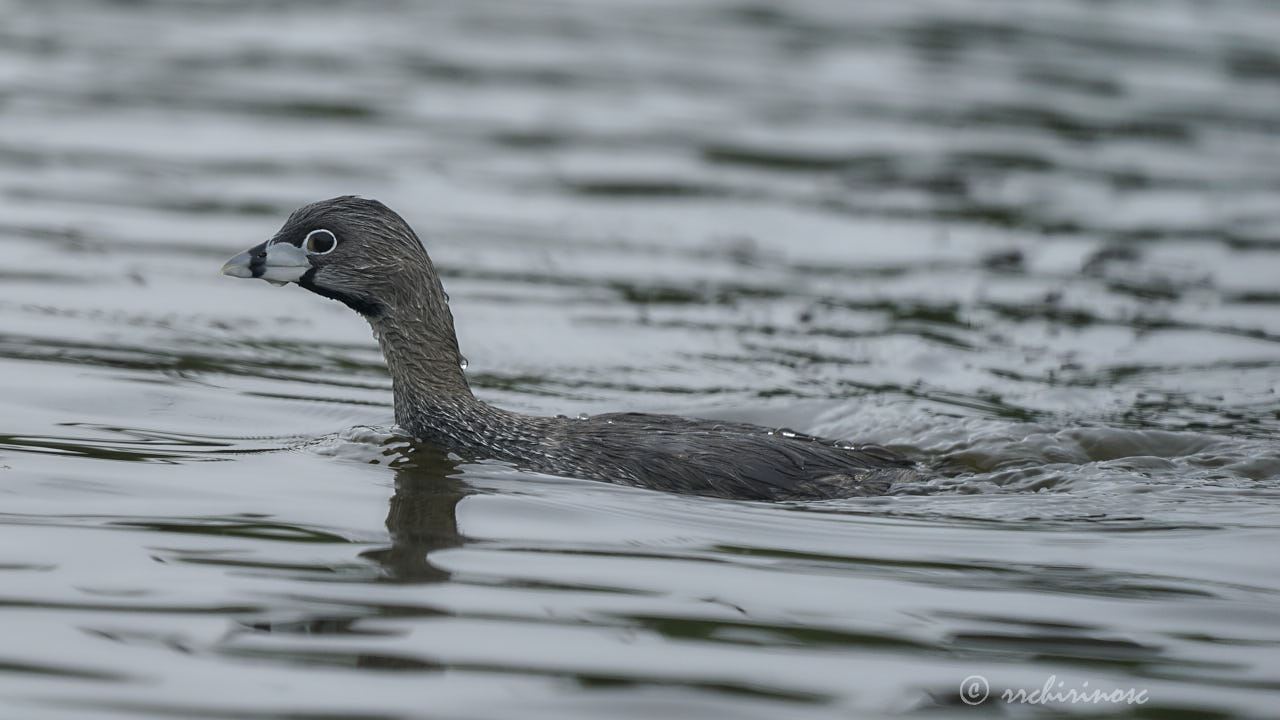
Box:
[223,196,918,501]
